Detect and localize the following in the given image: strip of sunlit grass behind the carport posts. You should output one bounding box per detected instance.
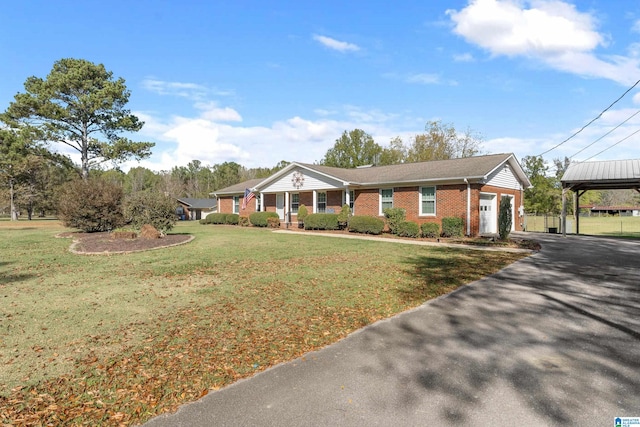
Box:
[527,216,640,238]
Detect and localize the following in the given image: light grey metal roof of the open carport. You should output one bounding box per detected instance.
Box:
[560,159,640,191]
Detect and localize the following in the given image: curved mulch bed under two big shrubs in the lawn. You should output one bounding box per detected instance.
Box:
[57,232,194,254]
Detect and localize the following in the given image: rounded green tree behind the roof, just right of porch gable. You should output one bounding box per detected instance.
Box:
[320,129,382,168]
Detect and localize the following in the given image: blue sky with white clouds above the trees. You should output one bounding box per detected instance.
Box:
[0,0,640,171]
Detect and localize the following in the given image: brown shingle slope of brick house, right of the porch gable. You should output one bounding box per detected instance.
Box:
[299,154,513,185]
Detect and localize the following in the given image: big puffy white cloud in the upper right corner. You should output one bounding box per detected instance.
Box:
[447,0,640,84]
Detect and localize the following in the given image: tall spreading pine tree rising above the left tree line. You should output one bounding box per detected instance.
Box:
[3,58,155,179]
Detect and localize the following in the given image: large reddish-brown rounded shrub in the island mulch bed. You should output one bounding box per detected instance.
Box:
[58,178,125,233]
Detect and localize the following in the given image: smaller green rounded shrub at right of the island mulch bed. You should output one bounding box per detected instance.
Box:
[123,191,176,233]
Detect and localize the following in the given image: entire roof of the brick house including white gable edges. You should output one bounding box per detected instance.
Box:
[256,153,531,190]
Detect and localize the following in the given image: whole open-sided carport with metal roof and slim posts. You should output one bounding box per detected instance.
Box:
[560,159,640,236]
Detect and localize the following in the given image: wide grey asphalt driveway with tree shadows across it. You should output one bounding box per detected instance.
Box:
[147,234,640,427]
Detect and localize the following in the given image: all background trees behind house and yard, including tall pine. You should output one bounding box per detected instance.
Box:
[0,58,640,219]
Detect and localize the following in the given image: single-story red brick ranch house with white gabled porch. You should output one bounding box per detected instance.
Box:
[212,154,531,236]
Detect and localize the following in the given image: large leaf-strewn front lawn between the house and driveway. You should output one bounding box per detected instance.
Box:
[0,221,524,424]
